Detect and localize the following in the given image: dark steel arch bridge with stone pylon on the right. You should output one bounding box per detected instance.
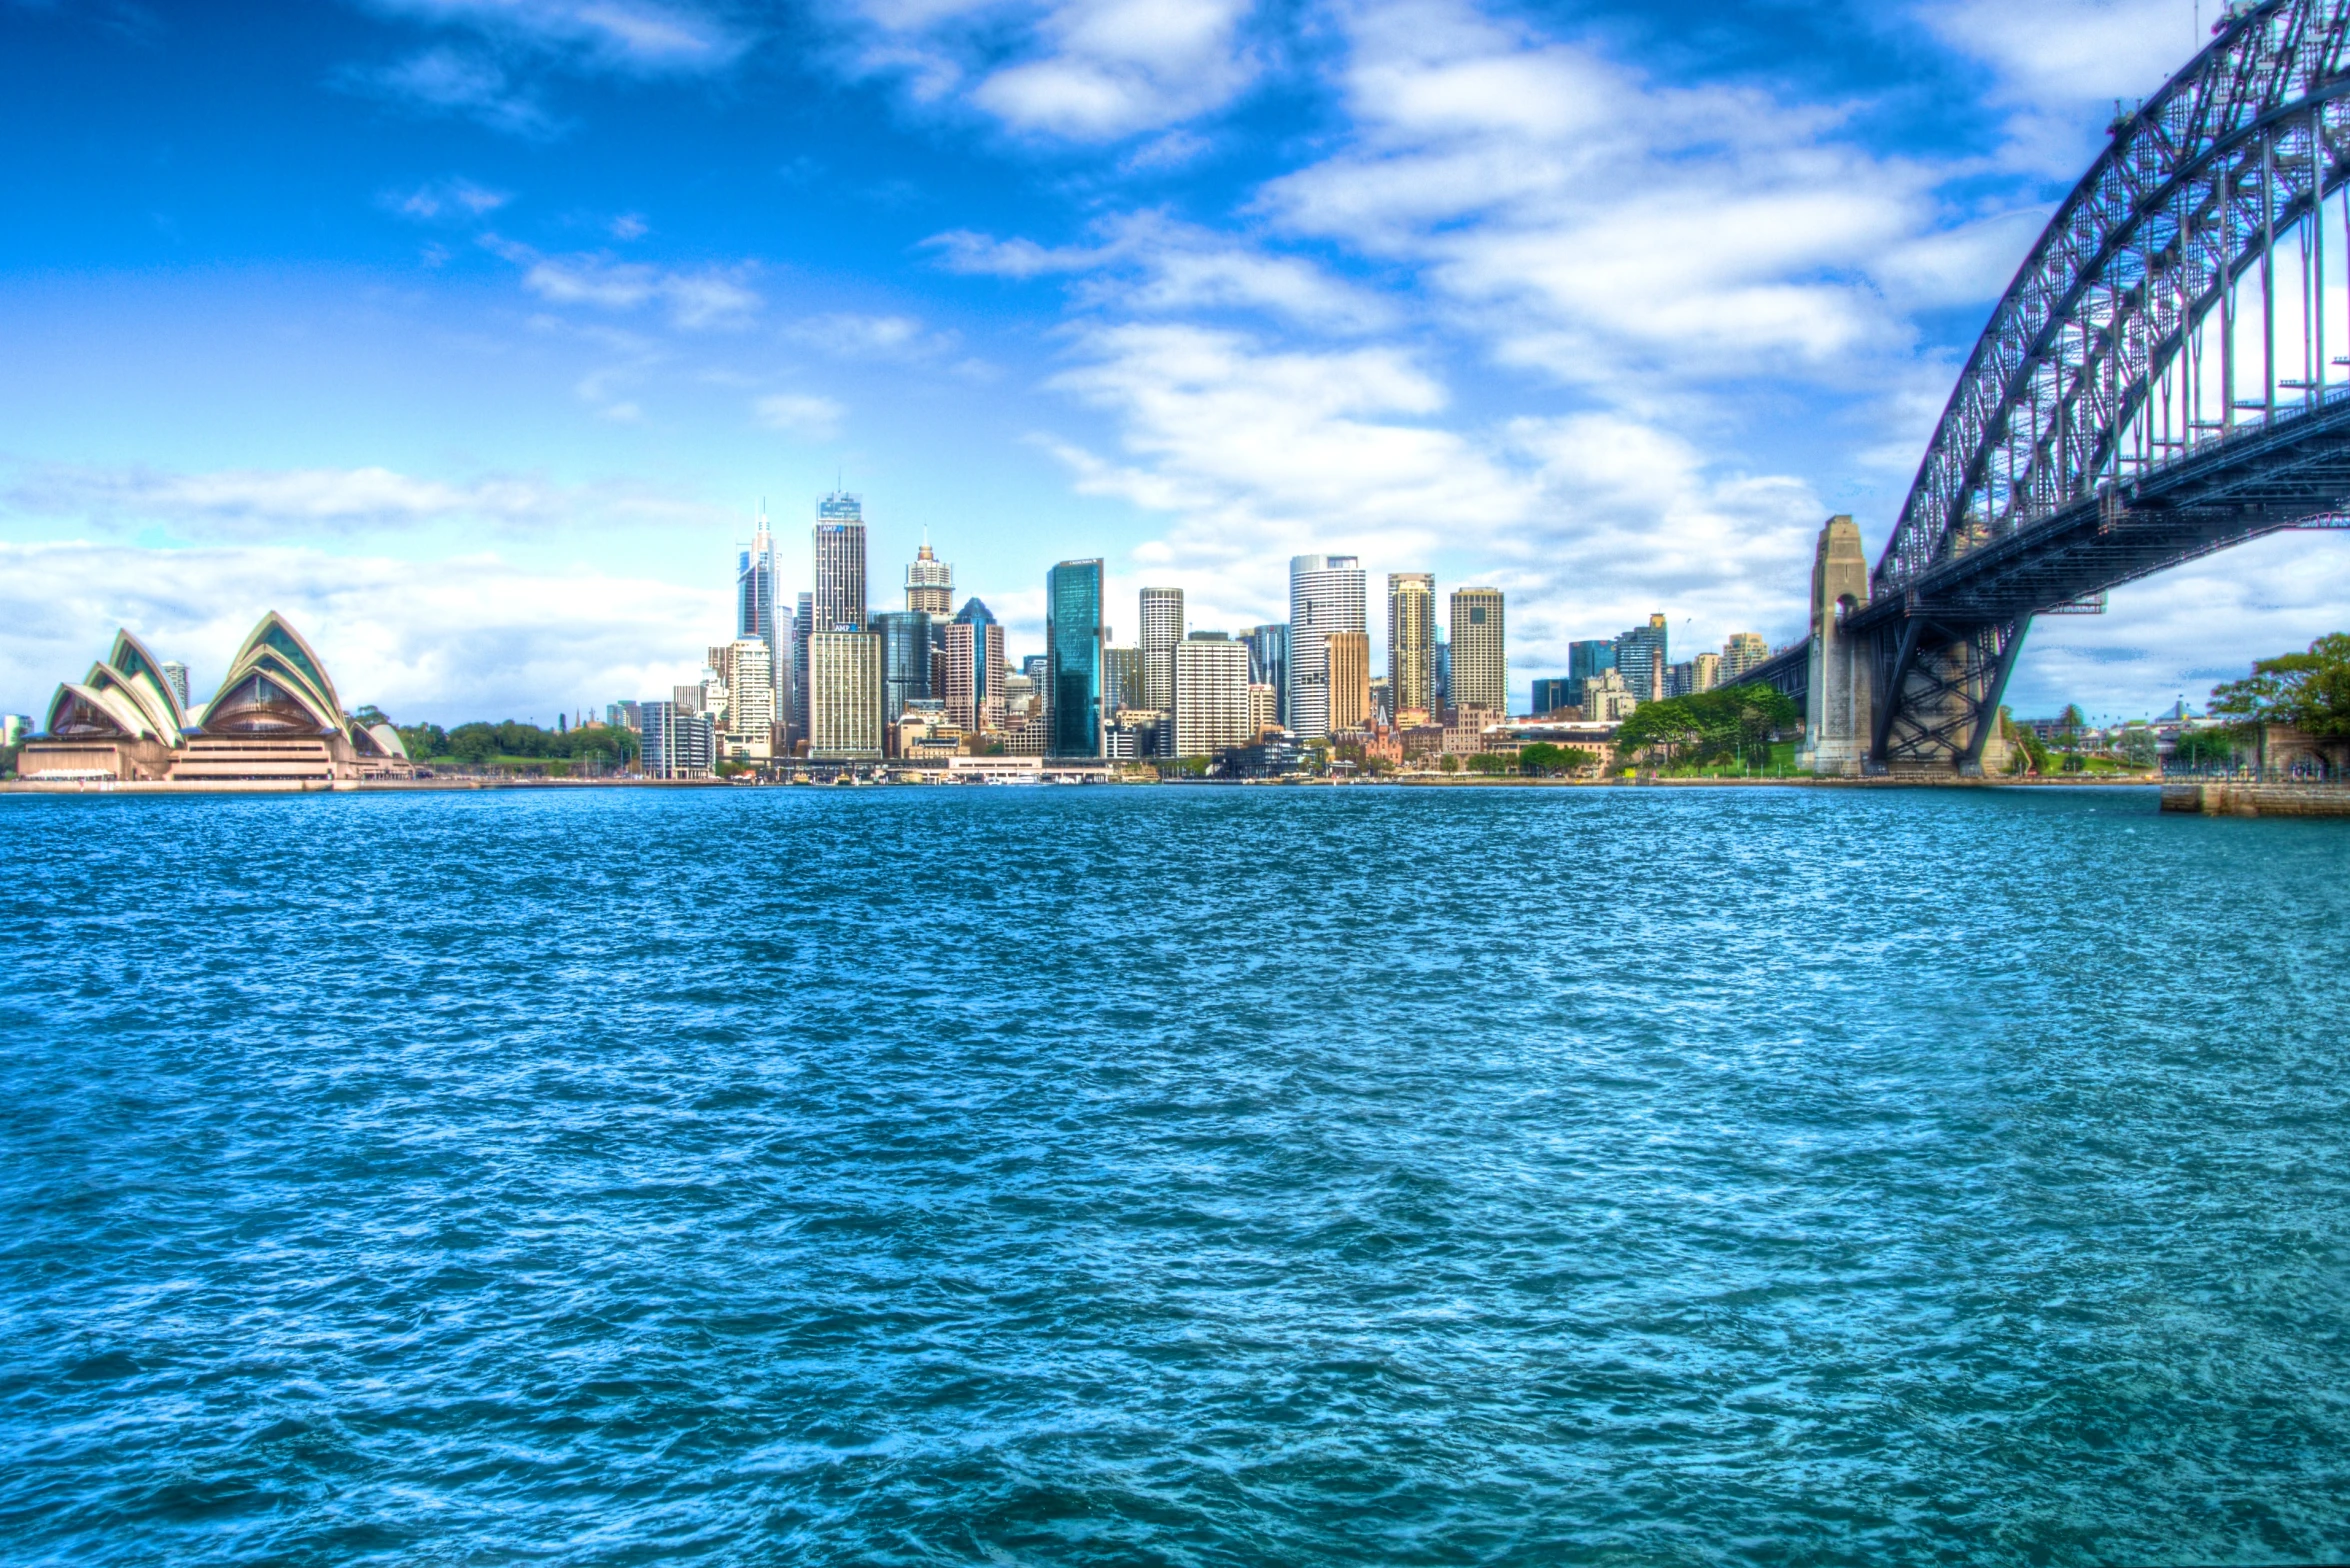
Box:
[1748,0,2350,771]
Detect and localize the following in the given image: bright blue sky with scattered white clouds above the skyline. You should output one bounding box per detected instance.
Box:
[0,0,2350,724]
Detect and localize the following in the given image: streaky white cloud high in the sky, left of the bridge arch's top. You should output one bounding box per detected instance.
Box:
[1260,0,1953,388]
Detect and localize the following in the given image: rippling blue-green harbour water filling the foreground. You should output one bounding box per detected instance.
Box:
[0,788,2350,1566]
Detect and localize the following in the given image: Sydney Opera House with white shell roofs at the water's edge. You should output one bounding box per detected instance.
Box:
[16,611,411,785]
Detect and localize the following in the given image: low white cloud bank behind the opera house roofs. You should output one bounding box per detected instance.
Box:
[0,541,729,724]
